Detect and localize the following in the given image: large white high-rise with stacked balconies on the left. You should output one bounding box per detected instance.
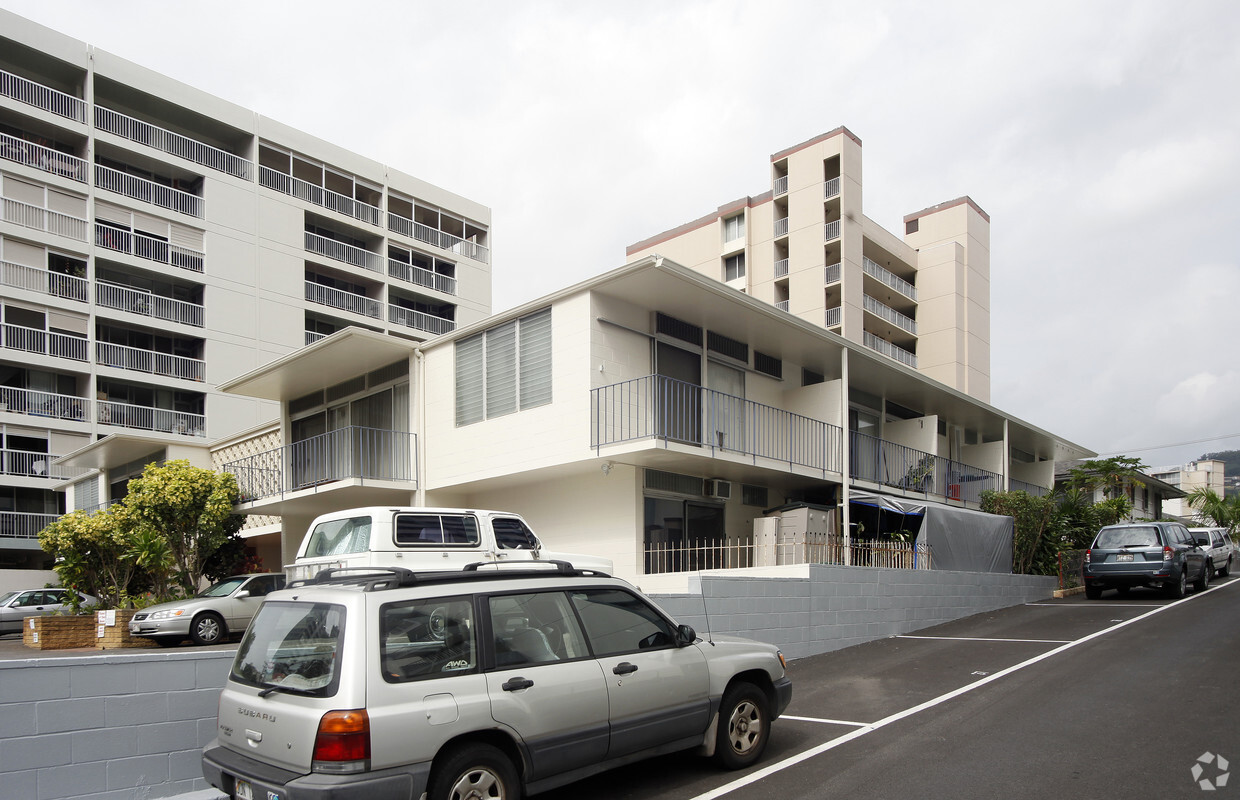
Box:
[0,10,491,569]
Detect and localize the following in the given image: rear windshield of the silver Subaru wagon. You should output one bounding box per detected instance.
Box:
[231,603,345,697]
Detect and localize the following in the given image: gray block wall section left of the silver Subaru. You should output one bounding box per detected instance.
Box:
[0,650,233,800]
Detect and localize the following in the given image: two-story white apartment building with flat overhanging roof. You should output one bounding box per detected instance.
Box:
[216,257,1091,587]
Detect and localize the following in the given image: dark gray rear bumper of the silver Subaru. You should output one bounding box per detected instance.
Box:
[202,739,430,800]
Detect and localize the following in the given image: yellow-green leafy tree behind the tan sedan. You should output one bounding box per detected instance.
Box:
[120,459,244,594]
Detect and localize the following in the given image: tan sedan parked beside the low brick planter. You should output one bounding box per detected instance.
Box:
[129,572,284,647]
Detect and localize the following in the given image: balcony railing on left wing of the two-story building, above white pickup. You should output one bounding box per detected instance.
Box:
[223,425,418,502]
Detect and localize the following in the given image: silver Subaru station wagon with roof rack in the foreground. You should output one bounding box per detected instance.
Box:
[202,562,792,800]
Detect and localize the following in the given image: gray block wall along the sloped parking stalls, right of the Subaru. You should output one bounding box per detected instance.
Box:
[652,566,1058,659]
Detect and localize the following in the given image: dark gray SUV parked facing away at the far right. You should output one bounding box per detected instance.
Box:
[1083,521,1211,600]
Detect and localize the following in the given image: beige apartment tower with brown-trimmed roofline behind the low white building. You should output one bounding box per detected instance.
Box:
[627,128,991,402]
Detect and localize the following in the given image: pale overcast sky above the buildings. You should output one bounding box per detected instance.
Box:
[0,0,1240,466]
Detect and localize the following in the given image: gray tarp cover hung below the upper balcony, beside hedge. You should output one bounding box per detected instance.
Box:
[849,491,1014,574]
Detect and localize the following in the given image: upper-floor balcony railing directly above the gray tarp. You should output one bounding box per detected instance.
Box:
[848,430,1003,502]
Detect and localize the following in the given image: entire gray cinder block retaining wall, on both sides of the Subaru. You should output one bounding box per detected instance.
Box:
[0,567,1056,800]
